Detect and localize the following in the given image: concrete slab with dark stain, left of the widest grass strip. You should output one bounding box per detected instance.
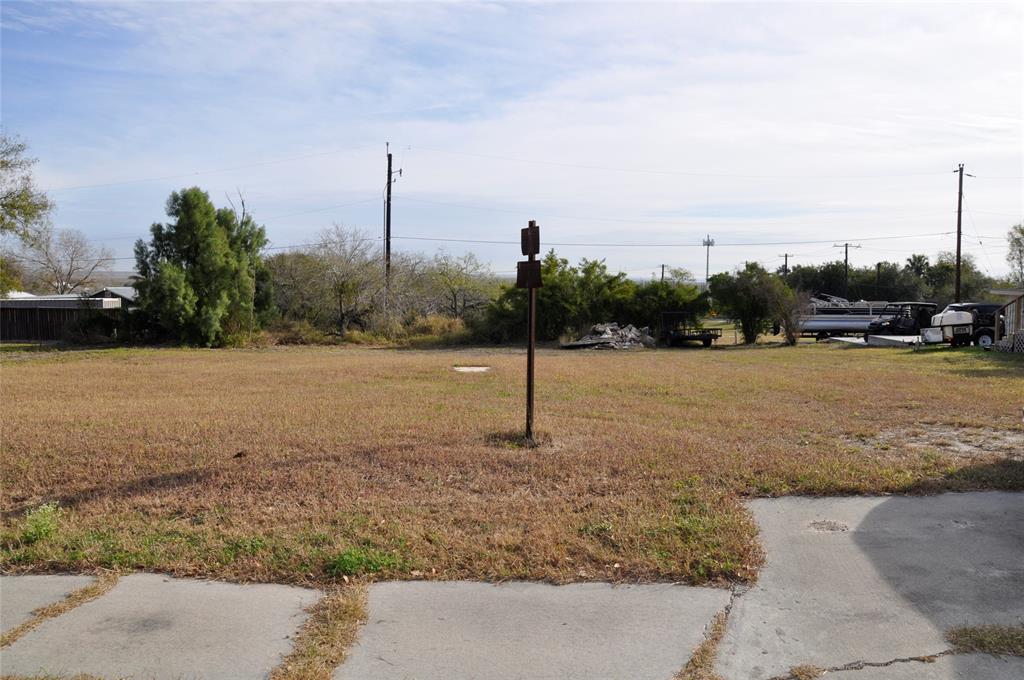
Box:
[0,573,319,680]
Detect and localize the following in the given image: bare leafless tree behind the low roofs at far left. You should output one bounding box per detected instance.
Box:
[20,226,112,295]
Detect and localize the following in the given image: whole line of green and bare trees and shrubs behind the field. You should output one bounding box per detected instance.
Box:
[6,136,1024,346]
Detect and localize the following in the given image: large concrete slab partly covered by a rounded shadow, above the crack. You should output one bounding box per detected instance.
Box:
[718,492,1024,680]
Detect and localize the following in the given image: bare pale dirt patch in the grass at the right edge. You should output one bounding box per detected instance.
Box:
[851,423,1024,461]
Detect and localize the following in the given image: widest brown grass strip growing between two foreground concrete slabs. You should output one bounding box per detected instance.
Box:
[270,585,367,680]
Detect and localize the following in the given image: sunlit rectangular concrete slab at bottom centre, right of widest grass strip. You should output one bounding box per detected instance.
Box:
[334,582,729,680]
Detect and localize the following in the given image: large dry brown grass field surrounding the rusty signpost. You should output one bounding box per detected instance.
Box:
[0,344,1024,583]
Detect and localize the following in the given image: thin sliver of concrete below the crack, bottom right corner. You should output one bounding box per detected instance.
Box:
[827,654,1024,680]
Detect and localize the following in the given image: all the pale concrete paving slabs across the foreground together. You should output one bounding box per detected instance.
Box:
[0,492,1024,680]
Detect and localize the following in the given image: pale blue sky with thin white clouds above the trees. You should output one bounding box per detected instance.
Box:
[0,0,1024,280]
